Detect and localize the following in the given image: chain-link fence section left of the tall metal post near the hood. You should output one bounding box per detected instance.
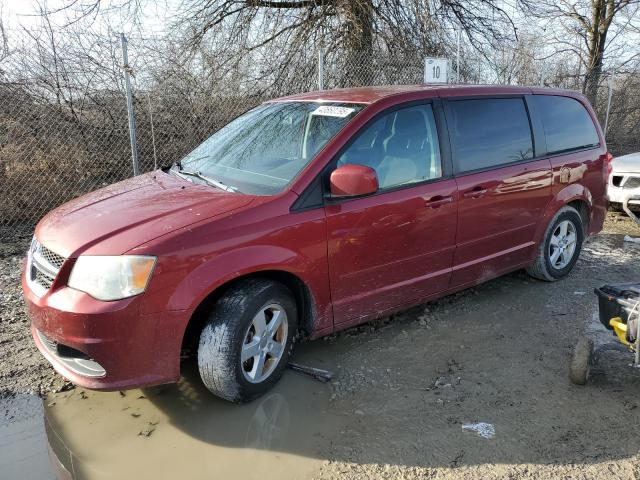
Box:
[0,83,131,236]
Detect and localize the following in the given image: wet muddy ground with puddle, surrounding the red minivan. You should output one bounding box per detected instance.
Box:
[0,214,640,480]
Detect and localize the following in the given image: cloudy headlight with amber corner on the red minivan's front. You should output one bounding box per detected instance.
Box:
[67,255,156,300]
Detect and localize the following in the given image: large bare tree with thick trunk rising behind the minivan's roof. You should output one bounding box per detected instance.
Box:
[178,0,513,85]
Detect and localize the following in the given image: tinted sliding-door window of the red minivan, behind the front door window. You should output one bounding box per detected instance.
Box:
[447,98,533,172]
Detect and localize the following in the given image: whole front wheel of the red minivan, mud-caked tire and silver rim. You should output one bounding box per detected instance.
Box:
[198,279,298,403]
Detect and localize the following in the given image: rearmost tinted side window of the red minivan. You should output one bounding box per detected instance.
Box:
[532,95,600,153]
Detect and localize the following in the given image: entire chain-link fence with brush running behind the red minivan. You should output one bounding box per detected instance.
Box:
[0,31,640,240]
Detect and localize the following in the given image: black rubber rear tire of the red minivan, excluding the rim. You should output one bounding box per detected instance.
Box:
[526,205,584,282]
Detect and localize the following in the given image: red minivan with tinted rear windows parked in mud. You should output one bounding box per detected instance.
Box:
[22,85,611,402]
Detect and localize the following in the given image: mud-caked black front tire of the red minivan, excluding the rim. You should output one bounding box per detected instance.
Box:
[198,279,298,403]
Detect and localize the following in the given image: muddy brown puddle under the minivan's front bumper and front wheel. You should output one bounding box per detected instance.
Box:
[0,344,346,480]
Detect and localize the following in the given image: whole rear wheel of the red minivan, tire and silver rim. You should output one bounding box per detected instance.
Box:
[527,206,584,282]
